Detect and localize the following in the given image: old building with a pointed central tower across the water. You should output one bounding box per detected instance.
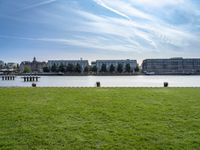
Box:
[20,57,47,73]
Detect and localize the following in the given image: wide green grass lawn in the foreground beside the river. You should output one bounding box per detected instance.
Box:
[0,88,200,150]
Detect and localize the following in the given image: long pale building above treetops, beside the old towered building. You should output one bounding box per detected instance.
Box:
[48,59,89,73]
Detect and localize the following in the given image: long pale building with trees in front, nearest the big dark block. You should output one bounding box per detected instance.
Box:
[91,59,137,73]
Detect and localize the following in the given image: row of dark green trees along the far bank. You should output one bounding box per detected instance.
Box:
[43,64,139,73]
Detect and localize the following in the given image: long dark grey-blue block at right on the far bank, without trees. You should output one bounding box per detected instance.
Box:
[142,57,200,75]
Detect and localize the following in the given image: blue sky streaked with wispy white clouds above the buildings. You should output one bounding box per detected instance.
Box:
[0,0,200,62]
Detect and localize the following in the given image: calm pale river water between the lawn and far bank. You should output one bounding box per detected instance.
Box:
[0,76,200,87]
